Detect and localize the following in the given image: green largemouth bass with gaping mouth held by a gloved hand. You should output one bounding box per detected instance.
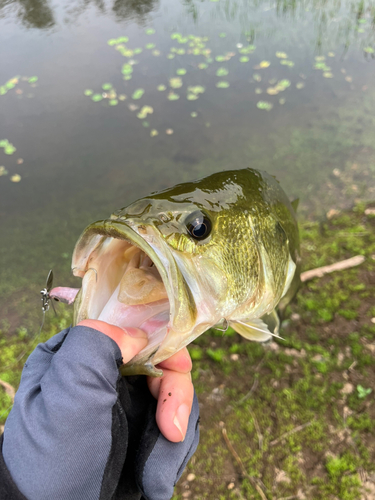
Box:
[51,168,300,376]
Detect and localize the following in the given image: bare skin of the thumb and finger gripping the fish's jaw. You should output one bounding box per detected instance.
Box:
[78,319,194,443]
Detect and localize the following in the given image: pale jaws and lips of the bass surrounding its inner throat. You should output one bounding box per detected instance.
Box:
[72,218,202,375]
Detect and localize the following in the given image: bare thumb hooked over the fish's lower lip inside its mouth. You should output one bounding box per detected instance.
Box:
[77,319,148,364]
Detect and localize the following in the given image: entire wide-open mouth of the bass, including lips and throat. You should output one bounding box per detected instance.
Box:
[72,219,198,375]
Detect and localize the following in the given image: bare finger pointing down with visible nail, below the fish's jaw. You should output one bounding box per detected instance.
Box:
[148,369,194,443]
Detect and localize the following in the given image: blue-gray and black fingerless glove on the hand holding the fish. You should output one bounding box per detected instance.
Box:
[0,326,199,500]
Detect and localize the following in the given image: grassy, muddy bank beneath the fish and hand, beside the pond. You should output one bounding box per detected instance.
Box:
[0,204,375,500]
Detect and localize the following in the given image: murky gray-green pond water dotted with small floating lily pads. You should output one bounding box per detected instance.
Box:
[0,0,375,328]
